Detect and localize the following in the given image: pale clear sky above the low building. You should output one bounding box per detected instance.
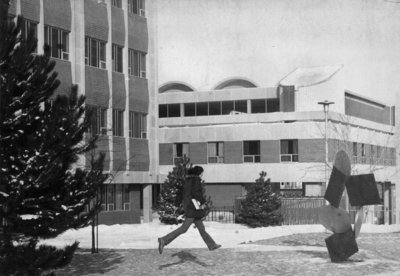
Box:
[157,0,400,105]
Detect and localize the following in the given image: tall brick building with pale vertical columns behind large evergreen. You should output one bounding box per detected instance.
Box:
[9,0,158,223]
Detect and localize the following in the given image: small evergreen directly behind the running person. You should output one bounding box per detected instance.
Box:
[156,156,212,224]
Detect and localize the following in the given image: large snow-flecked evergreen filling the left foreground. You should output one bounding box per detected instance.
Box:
[0,1,106,275]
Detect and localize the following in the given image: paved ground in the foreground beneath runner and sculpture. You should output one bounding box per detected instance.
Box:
[56,233,400,276]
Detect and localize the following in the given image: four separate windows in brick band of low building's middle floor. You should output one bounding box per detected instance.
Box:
[173,140,299,163]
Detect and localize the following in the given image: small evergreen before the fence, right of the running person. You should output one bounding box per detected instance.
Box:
[236,171,283,227]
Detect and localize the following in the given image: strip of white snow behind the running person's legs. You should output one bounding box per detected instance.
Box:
[42,219,400,249]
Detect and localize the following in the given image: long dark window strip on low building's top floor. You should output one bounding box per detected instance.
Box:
[158,98,279,118]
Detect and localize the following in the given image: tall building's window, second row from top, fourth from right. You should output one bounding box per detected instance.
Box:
[44,25,69,60]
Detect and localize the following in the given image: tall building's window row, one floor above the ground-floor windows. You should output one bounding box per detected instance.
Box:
[86,105,147,139]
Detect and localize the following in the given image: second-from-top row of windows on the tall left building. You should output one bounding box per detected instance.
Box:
[16,19,146,78]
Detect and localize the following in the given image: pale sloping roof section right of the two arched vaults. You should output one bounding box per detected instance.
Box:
[279,65,343,89]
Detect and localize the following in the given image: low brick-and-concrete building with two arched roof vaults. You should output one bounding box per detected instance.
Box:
[158,66,396,224]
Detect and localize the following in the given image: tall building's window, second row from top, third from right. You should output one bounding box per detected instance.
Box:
[85,37,106,69]
